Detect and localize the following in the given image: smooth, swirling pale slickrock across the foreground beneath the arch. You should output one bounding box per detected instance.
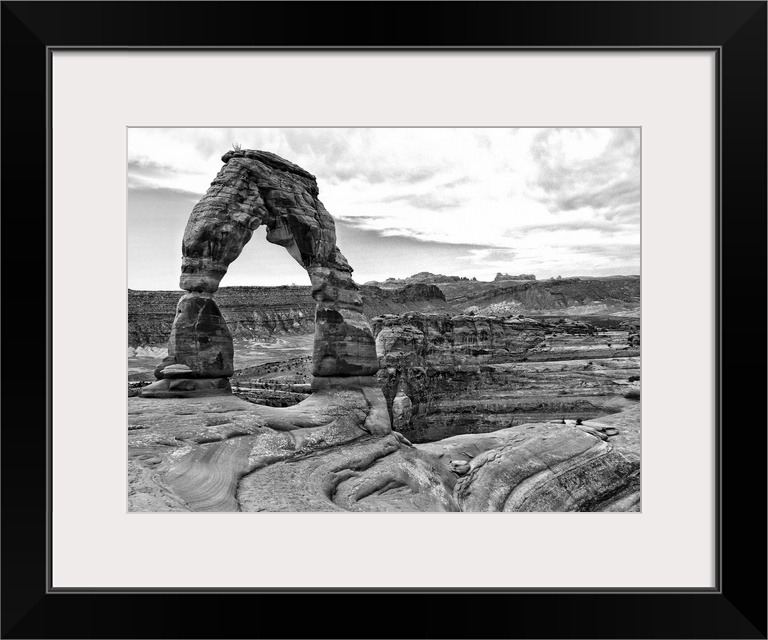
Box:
[128,398,639,512]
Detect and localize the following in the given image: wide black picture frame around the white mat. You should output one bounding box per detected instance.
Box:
[1,1,767,638]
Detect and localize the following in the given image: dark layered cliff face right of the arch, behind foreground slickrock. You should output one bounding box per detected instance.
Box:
[372,313,640,442]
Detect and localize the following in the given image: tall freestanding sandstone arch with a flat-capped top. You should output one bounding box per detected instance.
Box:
[142,150,379,397]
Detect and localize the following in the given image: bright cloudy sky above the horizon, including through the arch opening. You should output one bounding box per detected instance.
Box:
[128,128,640,289]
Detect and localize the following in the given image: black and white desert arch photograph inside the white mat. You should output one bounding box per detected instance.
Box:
[127,127,641,513]
